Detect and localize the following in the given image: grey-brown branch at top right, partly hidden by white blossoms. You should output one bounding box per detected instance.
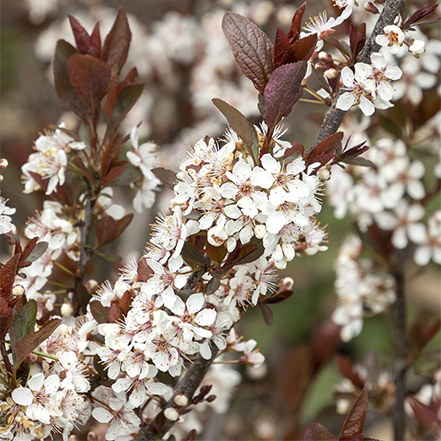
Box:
[314,0,404,145]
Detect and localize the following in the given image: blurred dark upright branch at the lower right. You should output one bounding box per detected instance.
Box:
[392,253,409,440]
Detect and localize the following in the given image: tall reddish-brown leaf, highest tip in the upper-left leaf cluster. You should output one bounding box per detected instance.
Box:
[101,8,132,88]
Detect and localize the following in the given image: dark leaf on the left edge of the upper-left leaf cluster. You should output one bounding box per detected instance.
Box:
[52,40,91,120]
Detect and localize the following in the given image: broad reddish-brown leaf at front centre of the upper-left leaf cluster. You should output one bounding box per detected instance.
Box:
[67,54,111,112]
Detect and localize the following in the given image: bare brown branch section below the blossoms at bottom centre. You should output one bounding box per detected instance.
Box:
[135,346,219,441]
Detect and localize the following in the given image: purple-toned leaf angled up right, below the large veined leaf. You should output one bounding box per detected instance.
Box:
[264,61,306,128]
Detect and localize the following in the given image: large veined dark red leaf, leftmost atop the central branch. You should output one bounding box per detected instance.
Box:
[222,12,274,94]
